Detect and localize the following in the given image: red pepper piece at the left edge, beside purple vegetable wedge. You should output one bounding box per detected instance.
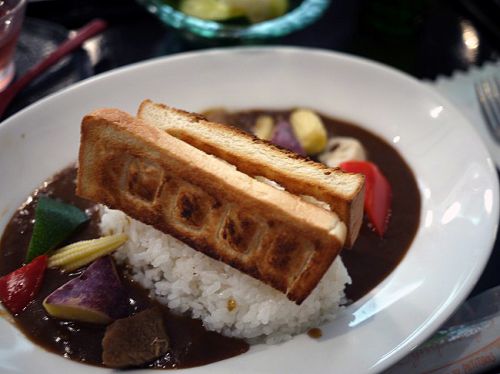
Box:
[0,255,48,314]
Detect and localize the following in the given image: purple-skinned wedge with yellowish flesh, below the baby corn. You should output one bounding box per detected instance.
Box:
[43,256,129,324]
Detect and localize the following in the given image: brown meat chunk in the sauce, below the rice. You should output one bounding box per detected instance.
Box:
[102,308,169,368]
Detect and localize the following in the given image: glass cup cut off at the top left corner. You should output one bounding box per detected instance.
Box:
[0,0,27,91]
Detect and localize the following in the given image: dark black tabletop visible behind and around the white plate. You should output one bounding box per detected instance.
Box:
[0,0,500,373]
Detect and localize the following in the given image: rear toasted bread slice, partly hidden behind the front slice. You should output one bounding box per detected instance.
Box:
[137,100,364,247]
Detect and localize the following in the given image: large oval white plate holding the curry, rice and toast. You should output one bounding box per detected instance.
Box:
[0,48,498,374]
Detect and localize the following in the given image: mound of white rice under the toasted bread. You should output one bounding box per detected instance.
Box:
[101,208,351,344]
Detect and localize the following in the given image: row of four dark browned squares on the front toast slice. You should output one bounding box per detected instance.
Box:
[123,161,314,296]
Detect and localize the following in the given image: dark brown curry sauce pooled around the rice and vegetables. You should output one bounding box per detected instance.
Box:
[0,111,420,369]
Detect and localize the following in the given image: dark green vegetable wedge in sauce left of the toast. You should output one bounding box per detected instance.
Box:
[26,196,89,262]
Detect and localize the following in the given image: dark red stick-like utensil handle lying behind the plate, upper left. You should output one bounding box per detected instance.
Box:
[0,19,107,118]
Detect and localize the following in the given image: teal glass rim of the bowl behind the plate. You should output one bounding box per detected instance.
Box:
[137,0,330,42]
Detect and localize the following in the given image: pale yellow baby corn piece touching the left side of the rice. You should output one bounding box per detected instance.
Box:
[49,234,128,271]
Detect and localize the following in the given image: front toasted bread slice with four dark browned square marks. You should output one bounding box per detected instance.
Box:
[77,109,347,304]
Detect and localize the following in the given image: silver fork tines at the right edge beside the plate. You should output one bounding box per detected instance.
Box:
[475,77,500,144]
